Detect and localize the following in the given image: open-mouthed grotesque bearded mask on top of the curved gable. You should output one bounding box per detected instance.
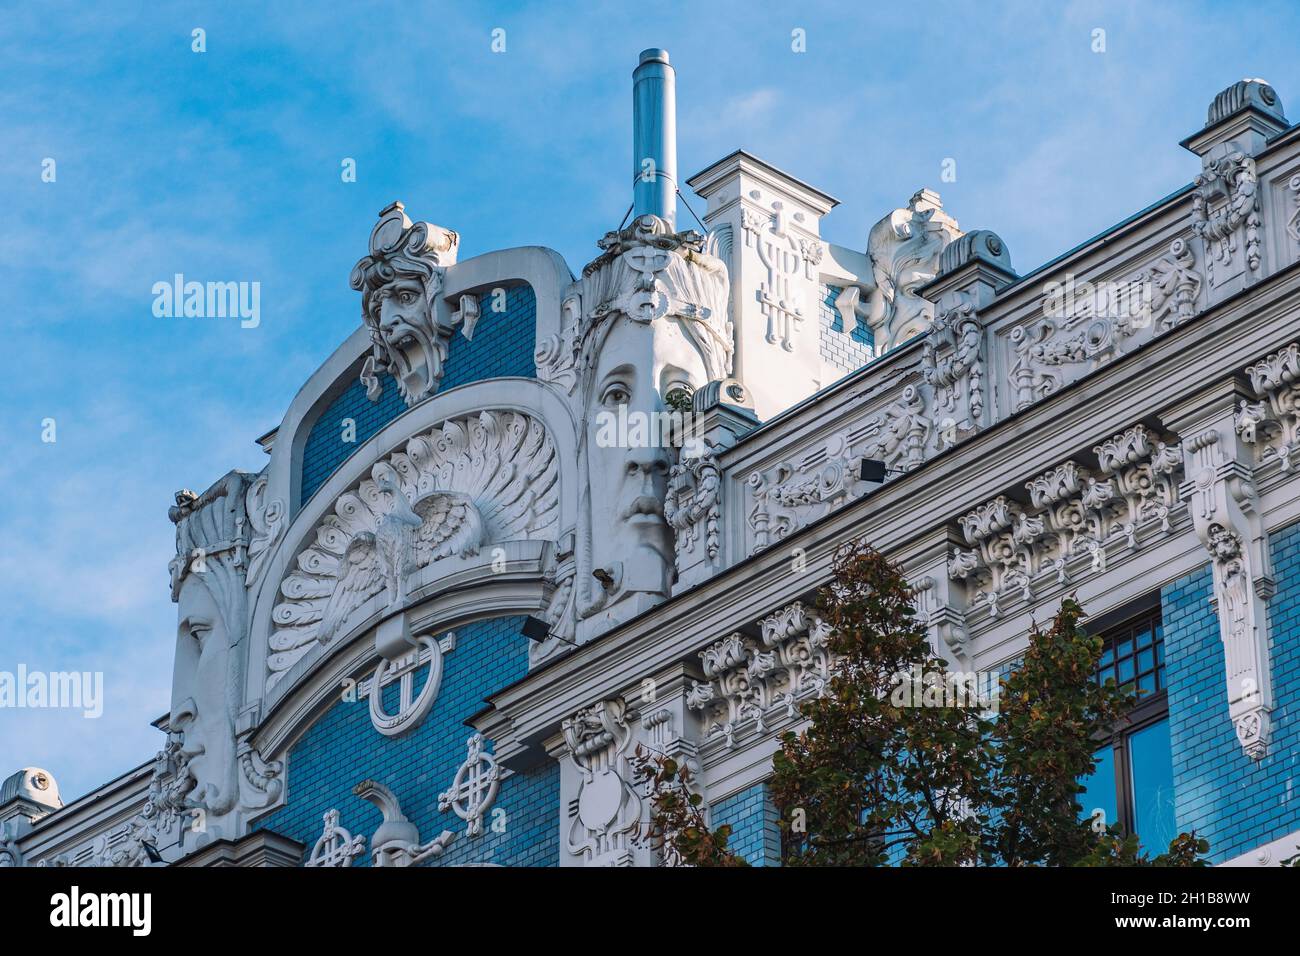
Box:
[351,203,459,405]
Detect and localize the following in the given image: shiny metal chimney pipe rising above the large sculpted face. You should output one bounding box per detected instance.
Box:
[632,49,677,230]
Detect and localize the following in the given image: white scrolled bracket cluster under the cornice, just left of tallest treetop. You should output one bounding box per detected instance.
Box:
[686,601,832,748]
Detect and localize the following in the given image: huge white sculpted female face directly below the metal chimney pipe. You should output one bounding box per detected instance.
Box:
[585,316,709,606]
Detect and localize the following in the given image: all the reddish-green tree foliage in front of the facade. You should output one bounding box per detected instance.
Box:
[638,541,1209,866]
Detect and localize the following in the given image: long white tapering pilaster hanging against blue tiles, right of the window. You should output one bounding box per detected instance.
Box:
[1165,380,1274,760]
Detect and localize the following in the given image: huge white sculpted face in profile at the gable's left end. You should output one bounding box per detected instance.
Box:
[172,571,239,814]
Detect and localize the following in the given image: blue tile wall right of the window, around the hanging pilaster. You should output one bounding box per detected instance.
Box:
[1161,524,1300,862]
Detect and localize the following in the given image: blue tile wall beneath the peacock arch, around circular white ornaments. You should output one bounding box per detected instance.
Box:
[256,617,560,866]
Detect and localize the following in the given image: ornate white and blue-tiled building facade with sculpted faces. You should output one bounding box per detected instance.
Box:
[0,51,1300,866]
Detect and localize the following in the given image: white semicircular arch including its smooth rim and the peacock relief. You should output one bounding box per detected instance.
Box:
[248,378,576,697]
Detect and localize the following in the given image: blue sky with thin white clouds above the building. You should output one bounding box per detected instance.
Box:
[0,0,1300,799]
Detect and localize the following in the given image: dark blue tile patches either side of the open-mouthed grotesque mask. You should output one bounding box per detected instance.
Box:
[299,285,537,503]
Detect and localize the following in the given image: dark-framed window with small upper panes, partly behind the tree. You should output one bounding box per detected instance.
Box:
[1079,601,1178,855]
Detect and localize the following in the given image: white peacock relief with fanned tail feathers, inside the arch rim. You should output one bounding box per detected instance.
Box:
[267,410,559,685]
